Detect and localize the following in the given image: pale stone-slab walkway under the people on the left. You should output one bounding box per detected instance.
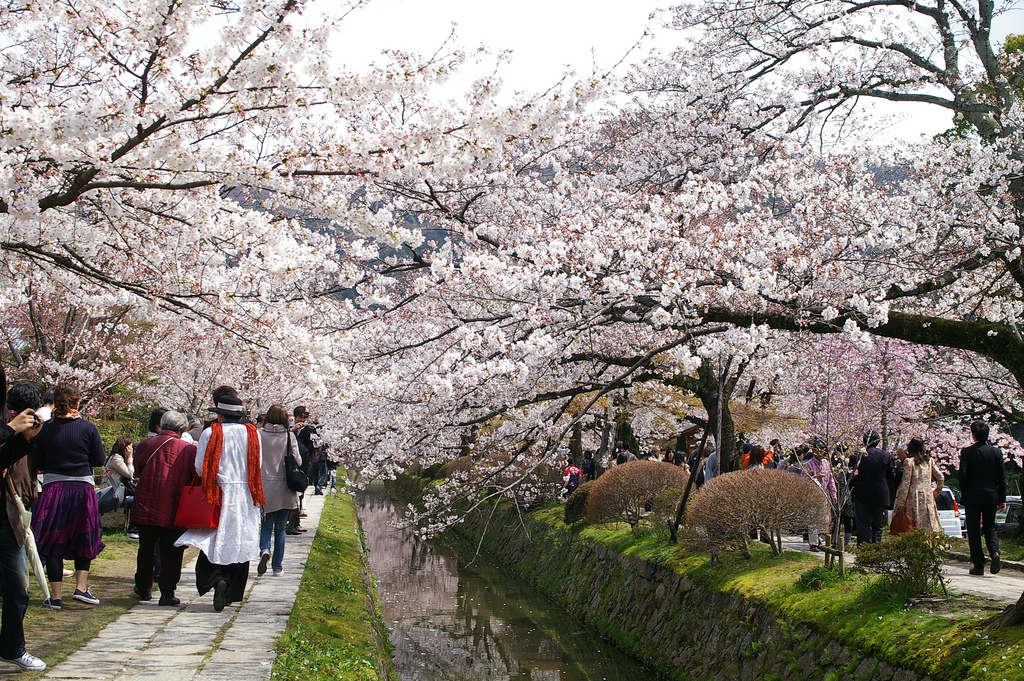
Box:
[43,494,325,681]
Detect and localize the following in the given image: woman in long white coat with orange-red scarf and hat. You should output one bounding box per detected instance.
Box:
[175,395,265,611]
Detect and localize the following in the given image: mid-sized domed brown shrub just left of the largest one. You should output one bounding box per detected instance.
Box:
[587,461,688,529]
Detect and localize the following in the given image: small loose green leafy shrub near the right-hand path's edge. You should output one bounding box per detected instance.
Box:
[857,529,949,596]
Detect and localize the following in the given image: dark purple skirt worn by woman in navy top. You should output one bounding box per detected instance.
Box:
[32,481,103,560]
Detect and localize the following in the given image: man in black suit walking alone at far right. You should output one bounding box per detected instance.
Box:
[957,421,1007,574]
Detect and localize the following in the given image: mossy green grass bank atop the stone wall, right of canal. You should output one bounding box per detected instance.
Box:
[531,504,1024,681]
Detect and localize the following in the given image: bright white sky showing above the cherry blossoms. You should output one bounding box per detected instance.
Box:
[325,0,1024,137]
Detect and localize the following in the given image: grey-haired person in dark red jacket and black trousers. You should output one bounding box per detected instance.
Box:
[131,410,196,605]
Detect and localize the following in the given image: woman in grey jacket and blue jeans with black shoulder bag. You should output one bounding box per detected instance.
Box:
[256,405,302,577]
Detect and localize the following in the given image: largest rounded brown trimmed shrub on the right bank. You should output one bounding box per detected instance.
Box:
[686,468,830,557]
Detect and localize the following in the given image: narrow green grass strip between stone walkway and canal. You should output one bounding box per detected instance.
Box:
[272,495,389,681]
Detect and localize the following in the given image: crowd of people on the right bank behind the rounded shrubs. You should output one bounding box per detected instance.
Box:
[563,421,1007,576]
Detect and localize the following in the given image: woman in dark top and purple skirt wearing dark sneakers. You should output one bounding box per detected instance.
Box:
[32,383,104,609]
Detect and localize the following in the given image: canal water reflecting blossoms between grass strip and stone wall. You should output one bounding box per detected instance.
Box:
[358,490,657,681]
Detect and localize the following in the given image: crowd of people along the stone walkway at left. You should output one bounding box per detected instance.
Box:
[0,368,325,672]
